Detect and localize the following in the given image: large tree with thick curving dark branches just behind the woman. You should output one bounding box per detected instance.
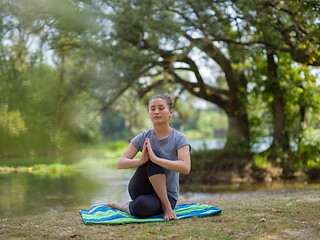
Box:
[101,1,249,151]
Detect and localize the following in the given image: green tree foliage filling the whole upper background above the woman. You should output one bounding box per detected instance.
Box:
[0,0,320,176]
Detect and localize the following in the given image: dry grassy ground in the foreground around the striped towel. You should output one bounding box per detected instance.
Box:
[0,188,320,239]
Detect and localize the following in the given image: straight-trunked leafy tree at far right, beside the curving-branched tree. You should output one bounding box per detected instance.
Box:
[233,0,320,151]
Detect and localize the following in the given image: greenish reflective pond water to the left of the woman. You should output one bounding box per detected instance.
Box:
[0,167,129,218]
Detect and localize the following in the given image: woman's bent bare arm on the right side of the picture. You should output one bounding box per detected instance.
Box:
[146,139,191,175]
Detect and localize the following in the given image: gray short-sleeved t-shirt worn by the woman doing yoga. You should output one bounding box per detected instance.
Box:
[131,128,191,201]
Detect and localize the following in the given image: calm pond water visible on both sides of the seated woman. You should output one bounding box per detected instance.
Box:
[0,140,320,219]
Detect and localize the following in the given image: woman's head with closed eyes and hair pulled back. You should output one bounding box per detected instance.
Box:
[149,98,173,124]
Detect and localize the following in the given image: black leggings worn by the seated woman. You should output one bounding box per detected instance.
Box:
[128,160,177,218]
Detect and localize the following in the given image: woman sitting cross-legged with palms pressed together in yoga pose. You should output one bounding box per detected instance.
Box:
[108,94,191,220]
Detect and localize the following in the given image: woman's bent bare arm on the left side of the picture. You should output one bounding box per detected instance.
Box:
[116,143,148,169]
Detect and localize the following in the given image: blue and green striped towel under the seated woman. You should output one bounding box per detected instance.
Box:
[79,203,221,224]
